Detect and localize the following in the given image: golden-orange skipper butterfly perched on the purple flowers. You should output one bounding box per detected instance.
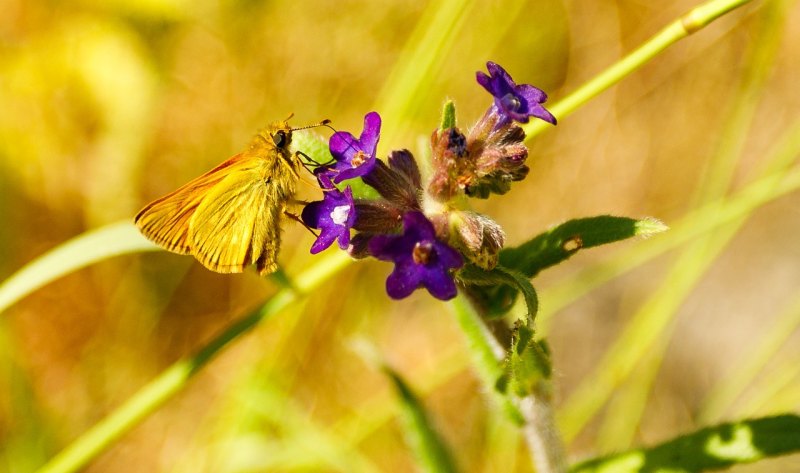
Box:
[135,117,329,275]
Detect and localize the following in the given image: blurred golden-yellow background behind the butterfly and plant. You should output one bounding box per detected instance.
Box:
[0,0,800,472]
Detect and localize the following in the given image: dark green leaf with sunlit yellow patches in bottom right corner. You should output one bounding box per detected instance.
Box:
[570,414,800,473]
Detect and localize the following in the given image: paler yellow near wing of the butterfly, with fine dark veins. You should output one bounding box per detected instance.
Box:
[189,159,289,274]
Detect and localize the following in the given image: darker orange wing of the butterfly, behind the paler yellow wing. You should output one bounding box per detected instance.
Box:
[135,155,253,255]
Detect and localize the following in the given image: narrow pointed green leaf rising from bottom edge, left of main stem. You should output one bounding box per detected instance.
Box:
[383,365,458,473]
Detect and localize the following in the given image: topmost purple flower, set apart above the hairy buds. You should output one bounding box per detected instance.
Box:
[476,61,556,128]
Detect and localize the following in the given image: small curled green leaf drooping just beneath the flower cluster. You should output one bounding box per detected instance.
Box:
[458,264,539,323]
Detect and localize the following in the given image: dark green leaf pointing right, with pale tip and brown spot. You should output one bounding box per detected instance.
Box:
[470,215,667,317]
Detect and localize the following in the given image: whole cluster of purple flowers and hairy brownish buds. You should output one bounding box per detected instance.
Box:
[302,62,556,300]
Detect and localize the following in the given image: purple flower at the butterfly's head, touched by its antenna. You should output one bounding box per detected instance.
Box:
[326,112,381,184]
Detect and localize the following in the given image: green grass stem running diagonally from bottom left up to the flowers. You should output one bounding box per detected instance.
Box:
[33,252,352,473]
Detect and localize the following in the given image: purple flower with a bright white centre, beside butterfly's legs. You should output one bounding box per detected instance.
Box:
[301,186,356,254]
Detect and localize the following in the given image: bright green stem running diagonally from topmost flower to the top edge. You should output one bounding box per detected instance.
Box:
[523,0,751,141]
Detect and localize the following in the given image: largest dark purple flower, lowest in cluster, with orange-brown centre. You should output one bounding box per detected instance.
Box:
[369,211,463,300]
